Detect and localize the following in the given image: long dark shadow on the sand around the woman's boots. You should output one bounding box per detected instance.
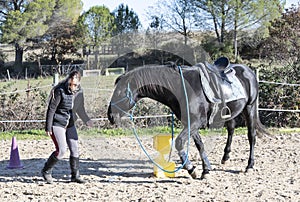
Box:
[0,158,188,183]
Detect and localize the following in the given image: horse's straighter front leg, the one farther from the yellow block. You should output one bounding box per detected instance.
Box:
[193,131,211,179]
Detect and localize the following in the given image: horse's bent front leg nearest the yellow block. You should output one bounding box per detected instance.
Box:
[175,129,197,179]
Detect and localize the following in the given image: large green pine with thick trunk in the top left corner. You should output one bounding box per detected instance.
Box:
[0,0,55,72]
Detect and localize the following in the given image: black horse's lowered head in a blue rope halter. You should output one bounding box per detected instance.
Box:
[107,75,136,124]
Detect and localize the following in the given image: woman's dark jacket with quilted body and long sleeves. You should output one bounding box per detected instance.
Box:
[45,81,90,131]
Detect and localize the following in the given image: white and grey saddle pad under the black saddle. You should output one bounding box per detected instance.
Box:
[199,68,246,103]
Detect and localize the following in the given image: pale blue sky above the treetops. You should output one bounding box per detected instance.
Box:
[82,0,300,27]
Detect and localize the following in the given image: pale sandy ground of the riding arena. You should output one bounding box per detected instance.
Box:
[0,134,300,202]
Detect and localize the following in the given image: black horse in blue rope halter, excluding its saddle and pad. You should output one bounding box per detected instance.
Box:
[107,61,266,178]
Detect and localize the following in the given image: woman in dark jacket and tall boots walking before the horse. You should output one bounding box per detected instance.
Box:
[42,71,93,184]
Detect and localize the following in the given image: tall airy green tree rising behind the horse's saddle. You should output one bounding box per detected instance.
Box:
[191,0,283,59]
